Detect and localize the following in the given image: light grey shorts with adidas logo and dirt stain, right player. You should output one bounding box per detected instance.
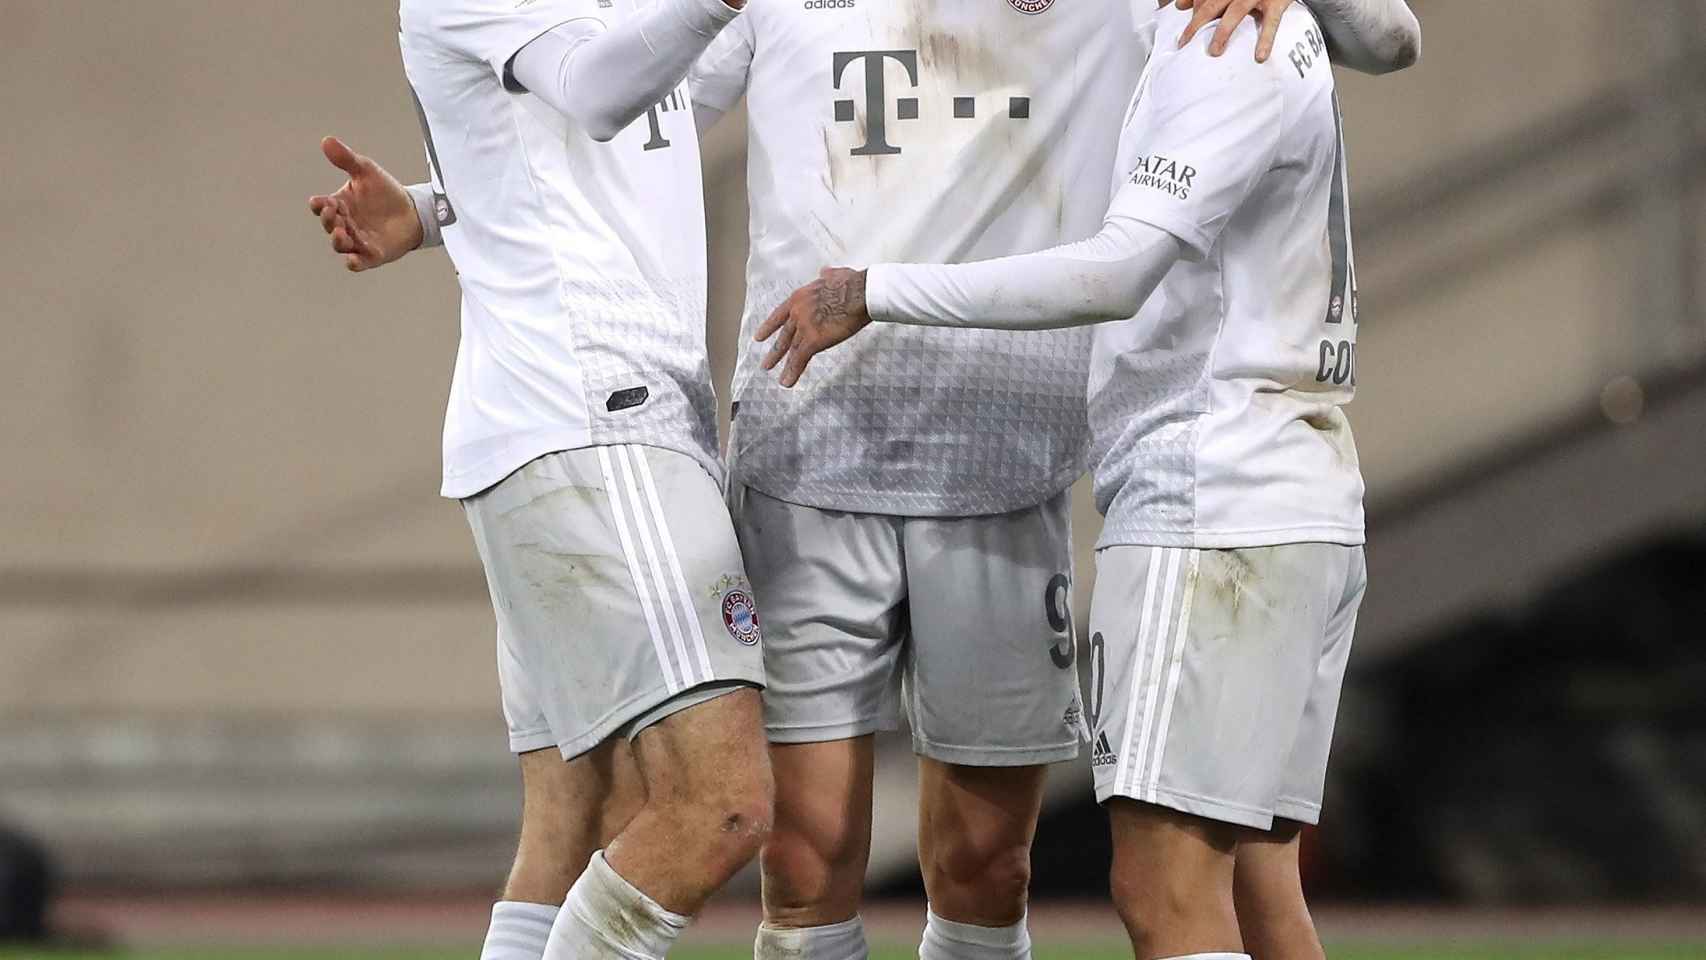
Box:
[1088,544,1368,830]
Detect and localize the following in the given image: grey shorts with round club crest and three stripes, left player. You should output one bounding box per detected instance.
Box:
[462,445,764,759]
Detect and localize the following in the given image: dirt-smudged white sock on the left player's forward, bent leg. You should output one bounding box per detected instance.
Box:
[544,851,693,960]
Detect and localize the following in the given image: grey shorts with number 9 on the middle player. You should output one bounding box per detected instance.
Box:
[734,488,1085,767]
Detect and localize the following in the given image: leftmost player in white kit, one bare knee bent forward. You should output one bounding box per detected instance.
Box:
[310,0,771,960]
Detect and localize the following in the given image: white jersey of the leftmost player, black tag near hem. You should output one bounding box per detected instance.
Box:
[399,0,720,498]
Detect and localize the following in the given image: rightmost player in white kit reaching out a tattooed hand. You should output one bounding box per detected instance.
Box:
[759,7,1412,960]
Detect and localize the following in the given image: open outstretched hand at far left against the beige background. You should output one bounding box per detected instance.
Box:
[309,136,423,273]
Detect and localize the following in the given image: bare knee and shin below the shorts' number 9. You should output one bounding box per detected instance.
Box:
[918,757,1047,926]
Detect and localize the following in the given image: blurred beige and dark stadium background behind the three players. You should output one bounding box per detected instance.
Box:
[0,0,1706,957]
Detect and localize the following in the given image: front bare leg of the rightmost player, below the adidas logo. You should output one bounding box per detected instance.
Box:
[1107,798,1244,960]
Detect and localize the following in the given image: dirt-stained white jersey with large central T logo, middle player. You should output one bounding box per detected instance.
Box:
[689,0,1153,517]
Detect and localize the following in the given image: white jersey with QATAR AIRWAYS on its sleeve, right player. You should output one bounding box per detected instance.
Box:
[1090,5,1363,547]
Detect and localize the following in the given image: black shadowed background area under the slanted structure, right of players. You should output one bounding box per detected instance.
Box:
[882,535,1706,905]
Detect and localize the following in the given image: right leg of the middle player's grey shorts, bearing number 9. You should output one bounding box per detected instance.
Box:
[904,491,1083,767]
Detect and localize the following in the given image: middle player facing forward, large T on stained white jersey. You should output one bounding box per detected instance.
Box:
[317,0,1402,960]
